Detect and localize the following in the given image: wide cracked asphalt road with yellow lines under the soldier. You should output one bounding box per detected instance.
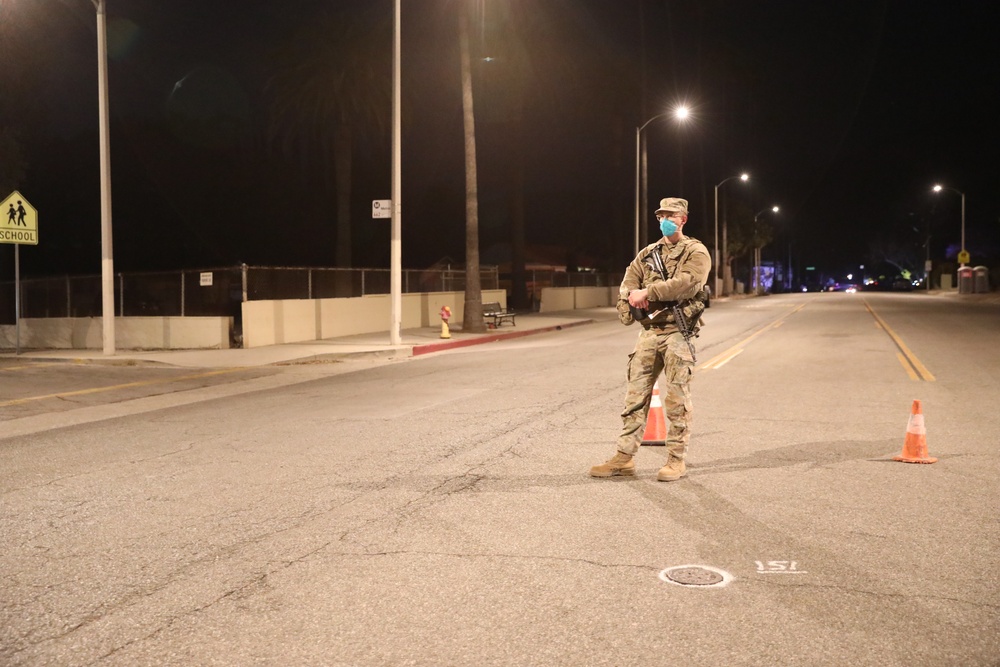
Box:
[0,294,1000,666]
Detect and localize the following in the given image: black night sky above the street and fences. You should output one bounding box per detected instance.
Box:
[0,0,1000,280]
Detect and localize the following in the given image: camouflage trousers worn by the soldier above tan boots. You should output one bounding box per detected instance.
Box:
[618,329,694,459]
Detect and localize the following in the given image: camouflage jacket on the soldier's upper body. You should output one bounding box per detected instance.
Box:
[618,237,712,333]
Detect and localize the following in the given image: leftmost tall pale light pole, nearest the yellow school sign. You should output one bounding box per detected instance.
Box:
[90,0,115,355]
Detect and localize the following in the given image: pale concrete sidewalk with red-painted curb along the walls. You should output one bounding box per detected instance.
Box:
[0,308,618,368]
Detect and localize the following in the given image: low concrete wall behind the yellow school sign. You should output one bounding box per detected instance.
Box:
[0,317,233,350]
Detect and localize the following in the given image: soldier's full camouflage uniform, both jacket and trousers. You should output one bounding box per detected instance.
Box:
[618,237,712,461]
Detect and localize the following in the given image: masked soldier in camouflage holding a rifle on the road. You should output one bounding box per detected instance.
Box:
[590,197,712,482]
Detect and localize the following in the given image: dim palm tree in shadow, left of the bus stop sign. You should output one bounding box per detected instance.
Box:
[265,8,392,267]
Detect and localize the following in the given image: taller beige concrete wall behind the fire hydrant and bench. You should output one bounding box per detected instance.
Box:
[243,290,507,348]
